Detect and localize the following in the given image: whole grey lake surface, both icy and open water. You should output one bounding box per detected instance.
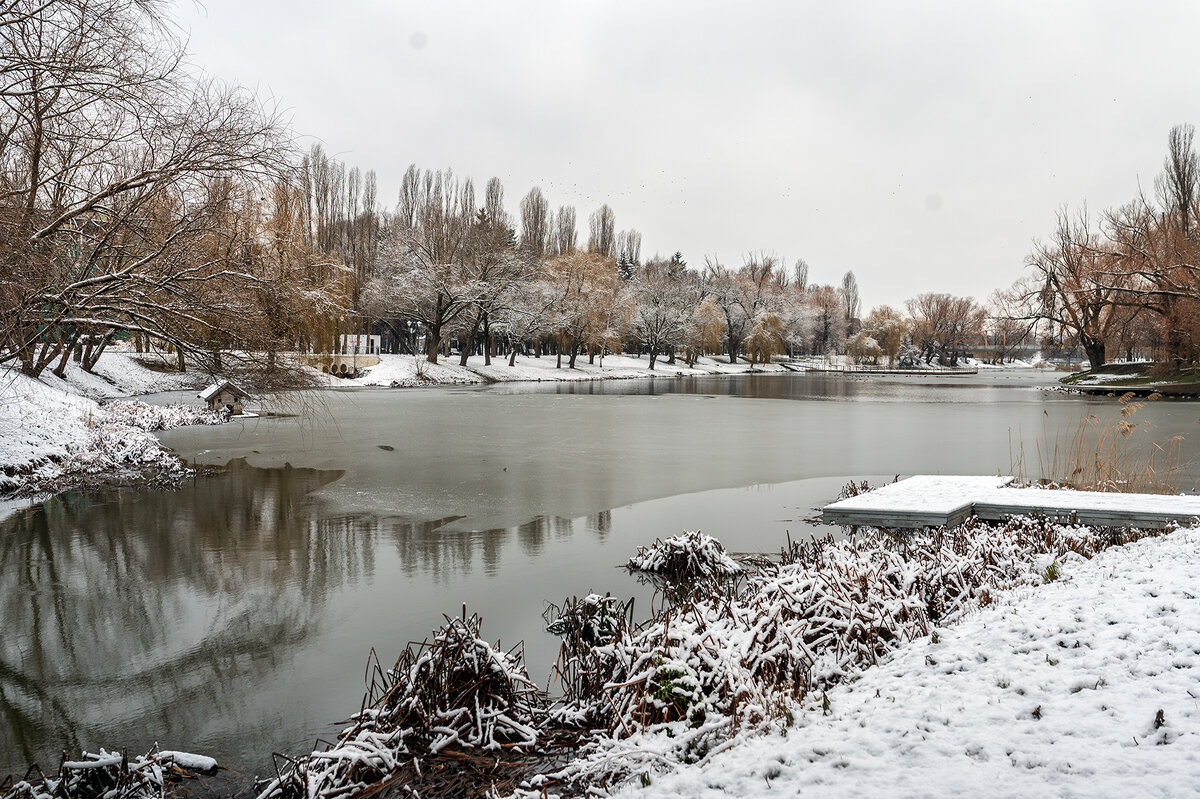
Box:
[0,372,1200,775]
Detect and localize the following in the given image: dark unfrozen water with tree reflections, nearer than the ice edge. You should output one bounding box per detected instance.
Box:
[0,462,854,774]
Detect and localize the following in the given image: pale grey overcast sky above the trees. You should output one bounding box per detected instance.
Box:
[179,0,1200,311]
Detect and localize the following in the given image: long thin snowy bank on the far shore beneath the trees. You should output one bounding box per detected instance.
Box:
[329,355,786,388]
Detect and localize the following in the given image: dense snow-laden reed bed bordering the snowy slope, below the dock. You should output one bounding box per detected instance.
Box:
[541,518,1145,791]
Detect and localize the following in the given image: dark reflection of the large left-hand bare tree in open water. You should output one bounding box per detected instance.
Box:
[0,469,377,774]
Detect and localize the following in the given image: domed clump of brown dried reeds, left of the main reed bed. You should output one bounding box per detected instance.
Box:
[259,612,546,799]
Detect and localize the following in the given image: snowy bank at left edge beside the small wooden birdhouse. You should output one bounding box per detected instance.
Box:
[0,371,224,495]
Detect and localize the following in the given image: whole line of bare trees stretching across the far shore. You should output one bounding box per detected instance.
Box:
[11,0,1200,382]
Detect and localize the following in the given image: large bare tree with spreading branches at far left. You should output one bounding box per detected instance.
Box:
[0,0,292,376]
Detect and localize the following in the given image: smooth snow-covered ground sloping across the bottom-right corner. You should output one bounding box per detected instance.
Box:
[625,529,1200,797]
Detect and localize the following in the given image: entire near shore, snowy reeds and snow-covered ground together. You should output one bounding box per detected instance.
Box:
[7,518,1200,799]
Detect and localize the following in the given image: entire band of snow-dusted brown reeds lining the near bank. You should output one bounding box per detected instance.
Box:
[238,518,1166,799]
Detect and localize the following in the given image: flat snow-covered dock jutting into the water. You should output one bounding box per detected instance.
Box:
[823,475,1200,528]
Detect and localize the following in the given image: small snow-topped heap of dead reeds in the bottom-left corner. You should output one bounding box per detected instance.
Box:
[0,747,217,799]
